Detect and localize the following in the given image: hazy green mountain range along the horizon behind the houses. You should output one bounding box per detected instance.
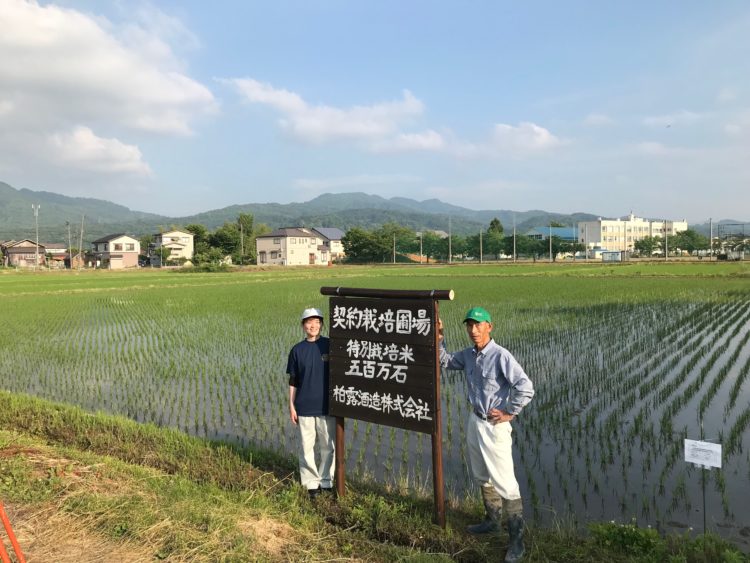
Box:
[0,182,742,242]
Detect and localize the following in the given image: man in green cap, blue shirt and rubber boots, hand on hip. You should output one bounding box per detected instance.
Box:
[438,307,534,563]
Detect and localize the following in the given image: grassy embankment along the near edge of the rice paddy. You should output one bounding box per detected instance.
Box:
[0,392,748,562]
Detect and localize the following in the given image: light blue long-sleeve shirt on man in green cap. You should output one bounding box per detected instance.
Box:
[440,340,534,417]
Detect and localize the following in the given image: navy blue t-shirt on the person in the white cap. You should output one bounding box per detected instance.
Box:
[286,336,329,416]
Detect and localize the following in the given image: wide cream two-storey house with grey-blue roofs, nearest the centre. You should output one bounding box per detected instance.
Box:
[255,227,344,266]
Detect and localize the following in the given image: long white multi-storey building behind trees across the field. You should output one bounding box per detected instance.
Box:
[578,213,688,251]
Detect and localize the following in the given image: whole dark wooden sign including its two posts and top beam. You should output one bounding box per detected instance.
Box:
[320,287,453,528]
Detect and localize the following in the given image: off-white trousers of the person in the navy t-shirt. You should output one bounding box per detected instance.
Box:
[297,416,336,490]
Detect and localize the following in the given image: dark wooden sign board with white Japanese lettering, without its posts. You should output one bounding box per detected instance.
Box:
[328,297,436,433]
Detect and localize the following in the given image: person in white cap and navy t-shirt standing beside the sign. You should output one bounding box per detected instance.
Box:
[286,308,336,498]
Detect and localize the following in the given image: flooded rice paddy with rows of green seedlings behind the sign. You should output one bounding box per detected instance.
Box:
[0,263,750,551]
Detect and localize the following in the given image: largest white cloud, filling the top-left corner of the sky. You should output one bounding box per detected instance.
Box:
[0,0,217,135]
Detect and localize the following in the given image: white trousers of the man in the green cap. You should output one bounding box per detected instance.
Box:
[466,412,521,500]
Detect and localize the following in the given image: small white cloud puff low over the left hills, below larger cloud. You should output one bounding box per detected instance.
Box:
[48,127,151,176]
